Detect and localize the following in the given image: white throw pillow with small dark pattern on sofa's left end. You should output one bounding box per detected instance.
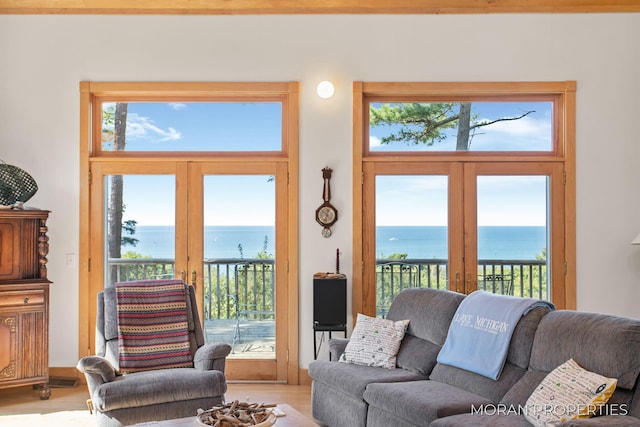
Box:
[340,313,409,369]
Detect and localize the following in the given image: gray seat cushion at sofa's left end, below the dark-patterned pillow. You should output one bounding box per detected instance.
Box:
[309,360,426,398]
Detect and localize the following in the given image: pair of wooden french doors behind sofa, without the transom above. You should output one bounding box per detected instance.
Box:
[362,161,565,316]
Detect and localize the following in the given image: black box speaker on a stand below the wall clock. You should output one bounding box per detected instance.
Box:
[313,279,347,326]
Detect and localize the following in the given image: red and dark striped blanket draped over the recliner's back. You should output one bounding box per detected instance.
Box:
[116,280,193,373]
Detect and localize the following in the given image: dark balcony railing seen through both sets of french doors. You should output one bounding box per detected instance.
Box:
[109,258,550,320]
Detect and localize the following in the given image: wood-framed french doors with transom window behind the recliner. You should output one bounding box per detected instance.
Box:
[79,82,299,384]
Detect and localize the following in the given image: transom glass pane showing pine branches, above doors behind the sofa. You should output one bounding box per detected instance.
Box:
[369,101,553,152]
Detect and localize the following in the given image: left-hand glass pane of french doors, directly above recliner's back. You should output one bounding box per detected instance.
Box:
[104,175,176,287]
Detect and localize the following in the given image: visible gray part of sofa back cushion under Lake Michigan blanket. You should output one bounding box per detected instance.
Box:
[430,307,550,402]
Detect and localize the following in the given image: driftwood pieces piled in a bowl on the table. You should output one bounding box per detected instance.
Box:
[196,400,276,427]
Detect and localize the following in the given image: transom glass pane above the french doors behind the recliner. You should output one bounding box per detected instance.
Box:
[101,101,282,151]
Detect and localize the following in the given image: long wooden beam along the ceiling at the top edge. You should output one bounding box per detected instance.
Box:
[0,0,640,15]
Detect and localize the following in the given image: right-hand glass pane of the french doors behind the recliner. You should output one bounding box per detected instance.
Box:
[203,175,276,359]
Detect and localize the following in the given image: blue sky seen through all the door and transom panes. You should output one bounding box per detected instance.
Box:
[105,102,552,225]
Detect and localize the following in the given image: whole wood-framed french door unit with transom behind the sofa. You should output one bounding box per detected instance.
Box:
[352,81,576,316]
